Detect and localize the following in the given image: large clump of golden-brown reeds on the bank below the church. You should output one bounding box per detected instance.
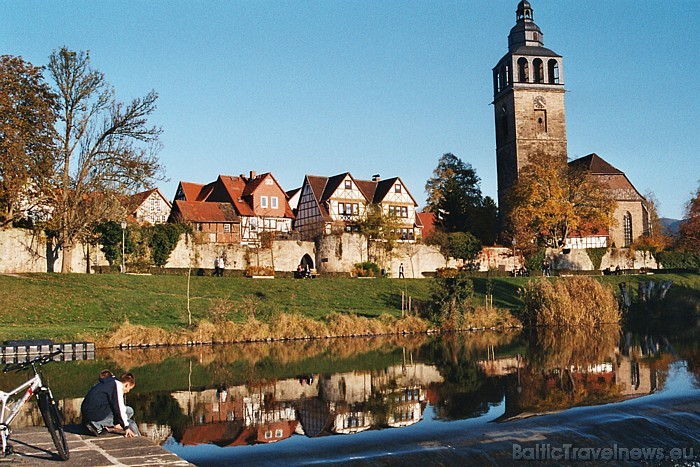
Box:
[518,276,620,326]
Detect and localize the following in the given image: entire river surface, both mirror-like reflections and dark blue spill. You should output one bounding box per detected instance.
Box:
[2,327,700,465]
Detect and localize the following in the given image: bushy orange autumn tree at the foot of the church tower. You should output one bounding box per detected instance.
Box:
[508,152,615,252]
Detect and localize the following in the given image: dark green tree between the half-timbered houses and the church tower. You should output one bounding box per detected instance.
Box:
[425,153,496,244]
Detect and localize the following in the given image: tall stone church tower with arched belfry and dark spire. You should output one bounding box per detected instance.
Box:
[493,0,567,218]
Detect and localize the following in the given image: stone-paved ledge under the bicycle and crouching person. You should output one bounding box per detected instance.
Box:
[0,425,192,467]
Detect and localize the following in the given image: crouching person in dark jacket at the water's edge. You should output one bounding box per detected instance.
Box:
[80,370,141,438]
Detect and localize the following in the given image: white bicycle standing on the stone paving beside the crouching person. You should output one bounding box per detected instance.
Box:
[0,349,70,461]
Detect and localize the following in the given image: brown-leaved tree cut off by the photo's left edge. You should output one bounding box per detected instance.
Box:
[0,55,56,227]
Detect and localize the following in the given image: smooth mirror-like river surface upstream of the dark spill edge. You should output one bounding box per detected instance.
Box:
[3,327,700,464]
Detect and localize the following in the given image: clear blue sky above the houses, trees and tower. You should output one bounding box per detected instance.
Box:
[0,0,700,218]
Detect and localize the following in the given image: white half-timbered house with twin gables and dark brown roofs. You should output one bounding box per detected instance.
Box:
[294,172,420,240]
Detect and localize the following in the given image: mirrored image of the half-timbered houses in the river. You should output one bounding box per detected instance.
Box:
[173,364,442,446]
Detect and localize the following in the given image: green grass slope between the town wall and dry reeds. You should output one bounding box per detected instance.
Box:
[0,274,700,340]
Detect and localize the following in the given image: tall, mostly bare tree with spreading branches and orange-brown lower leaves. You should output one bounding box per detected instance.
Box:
[48,48,161,272]
